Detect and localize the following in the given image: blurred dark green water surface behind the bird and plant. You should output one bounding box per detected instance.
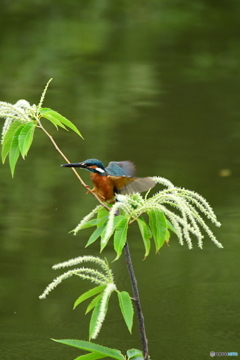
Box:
[0,0,240,360]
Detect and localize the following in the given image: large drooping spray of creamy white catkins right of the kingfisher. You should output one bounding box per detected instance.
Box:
[113,176,222,249]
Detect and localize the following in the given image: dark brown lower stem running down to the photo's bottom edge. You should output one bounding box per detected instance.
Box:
[124,242,149,360]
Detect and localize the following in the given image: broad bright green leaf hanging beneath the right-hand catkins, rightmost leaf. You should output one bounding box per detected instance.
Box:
[148,210,167,252]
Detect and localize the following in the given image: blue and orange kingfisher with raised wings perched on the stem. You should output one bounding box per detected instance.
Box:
[61,159,156,204]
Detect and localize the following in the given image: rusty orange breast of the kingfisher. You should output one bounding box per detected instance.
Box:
[91,173,114,202]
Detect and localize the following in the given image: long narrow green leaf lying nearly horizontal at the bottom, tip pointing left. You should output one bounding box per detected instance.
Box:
[52,339,124,360]
